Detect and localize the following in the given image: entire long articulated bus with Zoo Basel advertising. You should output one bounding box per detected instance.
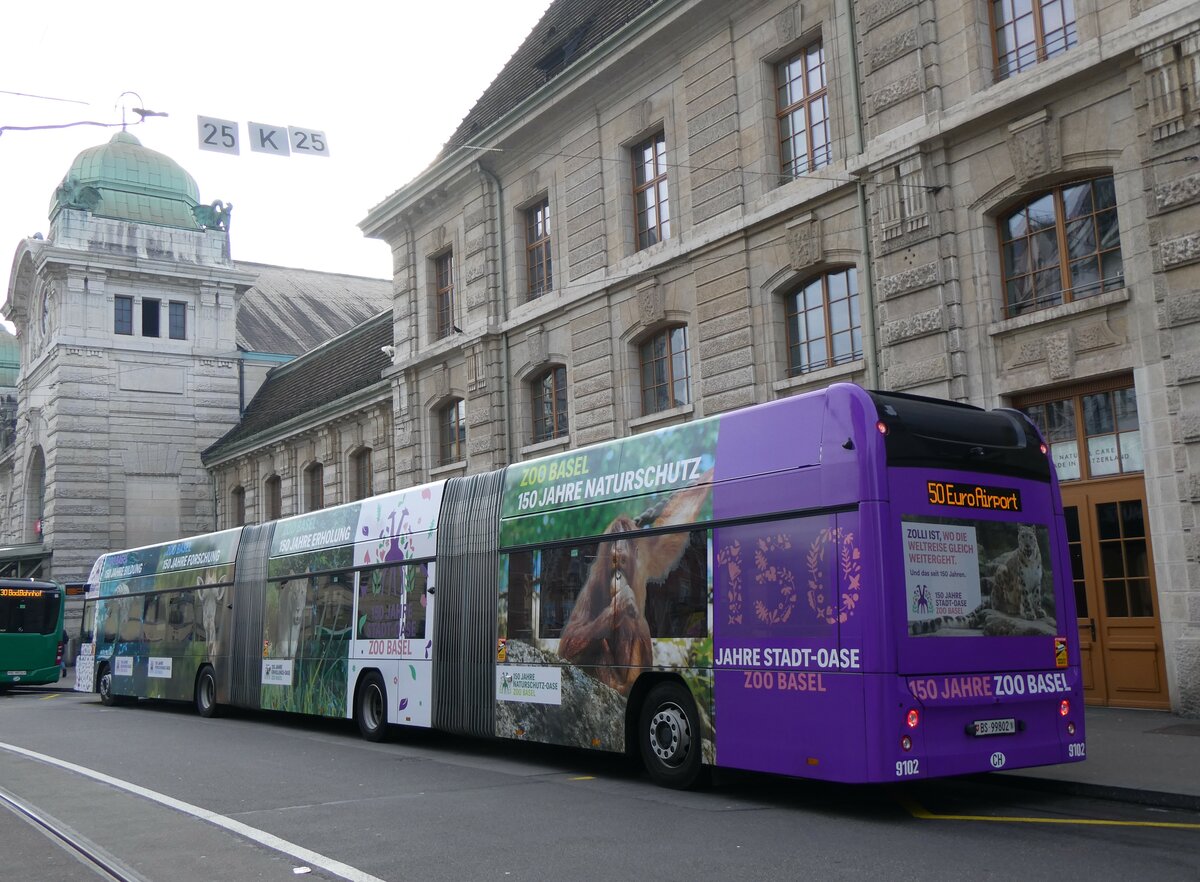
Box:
[78,384,1085,787]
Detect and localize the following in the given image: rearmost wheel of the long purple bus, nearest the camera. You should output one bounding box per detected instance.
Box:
[637,680,702,790]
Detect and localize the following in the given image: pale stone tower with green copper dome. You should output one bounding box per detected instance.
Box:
[0,131,254,582]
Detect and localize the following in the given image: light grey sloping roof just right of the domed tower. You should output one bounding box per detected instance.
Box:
[234,260,391,355]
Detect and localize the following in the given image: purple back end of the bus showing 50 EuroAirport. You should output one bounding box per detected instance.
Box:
[871,394,1085,779]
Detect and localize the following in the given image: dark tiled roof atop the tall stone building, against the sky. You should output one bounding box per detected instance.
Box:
[438,0,658,158]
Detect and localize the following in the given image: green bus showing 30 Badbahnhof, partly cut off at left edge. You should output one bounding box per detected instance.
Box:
[0,578,66,692]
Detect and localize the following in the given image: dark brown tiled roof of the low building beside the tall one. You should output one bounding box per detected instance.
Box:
[203,310,392,462]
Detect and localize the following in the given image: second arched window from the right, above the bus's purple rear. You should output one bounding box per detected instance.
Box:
[784,266,863,377]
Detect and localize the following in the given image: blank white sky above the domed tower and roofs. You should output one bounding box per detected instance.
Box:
[0,0,551,330]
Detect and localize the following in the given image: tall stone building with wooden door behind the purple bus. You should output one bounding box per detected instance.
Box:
[206,0,1200,715]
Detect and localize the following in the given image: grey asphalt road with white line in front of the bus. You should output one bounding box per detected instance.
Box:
[0,690,1200,882]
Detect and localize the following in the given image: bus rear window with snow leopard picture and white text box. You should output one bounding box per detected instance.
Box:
[900,515,1057,637]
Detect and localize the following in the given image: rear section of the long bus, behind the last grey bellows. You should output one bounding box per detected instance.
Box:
[496,384,1084,786]
